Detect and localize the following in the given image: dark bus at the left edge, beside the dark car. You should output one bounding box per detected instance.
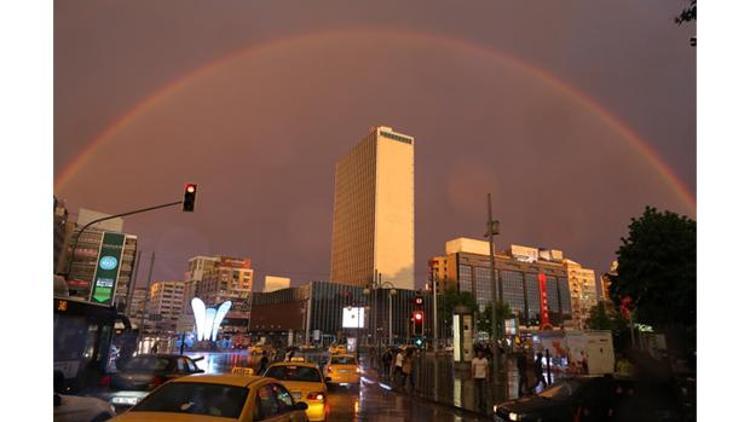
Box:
[53,296,135,394]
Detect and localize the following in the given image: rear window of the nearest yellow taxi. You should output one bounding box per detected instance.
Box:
[131,382,248,419]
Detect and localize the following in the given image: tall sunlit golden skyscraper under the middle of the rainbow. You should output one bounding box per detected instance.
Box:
[331,126,414,289]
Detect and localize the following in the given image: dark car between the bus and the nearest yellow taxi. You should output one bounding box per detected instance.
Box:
[108,354,204,409]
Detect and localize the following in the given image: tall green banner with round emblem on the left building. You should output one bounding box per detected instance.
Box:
[91,232,125,305]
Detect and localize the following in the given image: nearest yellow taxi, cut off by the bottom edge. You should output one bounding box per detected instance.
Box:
[111,375,307,422]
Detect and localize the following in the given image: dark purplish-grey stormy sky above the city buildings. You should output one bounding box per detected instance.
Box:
[54,0,696,285]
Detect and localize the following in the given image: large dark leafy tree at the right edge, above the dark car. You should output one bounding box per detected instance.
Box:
[610,207,697,356]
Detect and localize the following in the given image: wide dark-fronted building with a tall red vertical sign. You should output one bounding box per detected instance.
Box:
[431,238,572,327]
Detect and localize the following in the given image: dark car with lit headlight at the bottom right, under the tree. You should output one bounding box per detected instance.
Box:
[493,376,684,422]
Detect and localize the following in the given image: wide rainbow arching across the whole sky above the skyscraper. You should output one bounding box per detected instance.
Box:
[55,28,696,211]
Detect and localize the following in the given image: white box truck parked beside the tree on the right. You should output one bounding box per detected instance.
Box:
[533,331,615,375]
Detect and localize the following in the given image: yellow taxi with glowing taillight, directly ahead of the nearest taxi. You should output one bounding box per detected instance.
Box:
[263,358,328,421]
